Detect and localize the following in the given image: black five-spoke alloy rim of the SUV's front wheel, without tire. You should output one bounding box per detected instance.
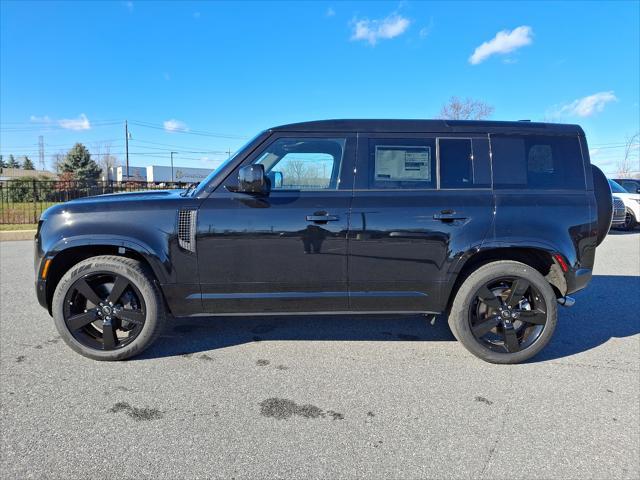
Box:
[63,271,146,350]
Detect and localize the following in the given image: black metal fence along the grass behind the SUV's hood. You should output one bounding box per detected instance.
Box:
[0,178,187,225]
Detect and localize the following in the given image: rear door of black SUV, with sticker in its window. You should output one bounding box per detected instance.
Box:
[349,134,493,312]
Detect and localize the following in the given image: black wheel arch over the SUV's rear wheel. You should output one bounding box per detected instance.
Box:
[443,247,567,311]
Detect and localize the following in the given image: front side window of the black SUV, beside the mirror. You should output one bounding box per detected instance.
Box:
[254,138,346,190]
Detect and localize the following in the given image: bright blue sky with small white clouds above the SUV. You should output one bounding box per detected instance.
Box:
[0,0,640,172]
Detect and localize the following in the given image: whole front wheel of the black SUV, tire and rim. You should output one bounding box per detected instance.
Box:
[52,256,166,361]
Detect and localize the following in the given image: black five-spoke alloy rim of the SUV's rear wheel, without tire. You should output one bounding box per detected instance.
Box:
[468,277,548,353]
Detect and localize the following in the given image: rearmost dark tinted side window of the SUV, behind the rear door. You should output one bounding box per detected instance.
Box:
[491,135,585,190]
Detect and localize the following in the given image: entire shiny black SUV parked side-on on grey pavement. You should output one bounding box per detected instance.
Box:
[35,120,611,363]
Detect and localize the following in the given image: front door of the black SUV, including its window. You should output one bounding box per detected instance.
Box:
[197,134,356,313]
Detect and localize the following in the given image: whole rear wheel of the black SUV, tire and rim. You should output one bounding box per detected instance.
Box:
[449,261,557,363]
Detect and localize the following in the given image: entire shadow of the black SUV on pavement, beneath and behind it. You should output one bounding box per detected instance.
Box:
[134,275,640,362]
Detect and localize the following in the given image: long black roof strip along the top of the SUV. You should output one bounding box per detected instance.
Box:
[270,119,584,135]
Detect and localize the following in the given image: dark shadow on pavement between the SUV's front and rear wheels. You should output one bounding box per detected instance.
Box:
[134,315,455,360]
